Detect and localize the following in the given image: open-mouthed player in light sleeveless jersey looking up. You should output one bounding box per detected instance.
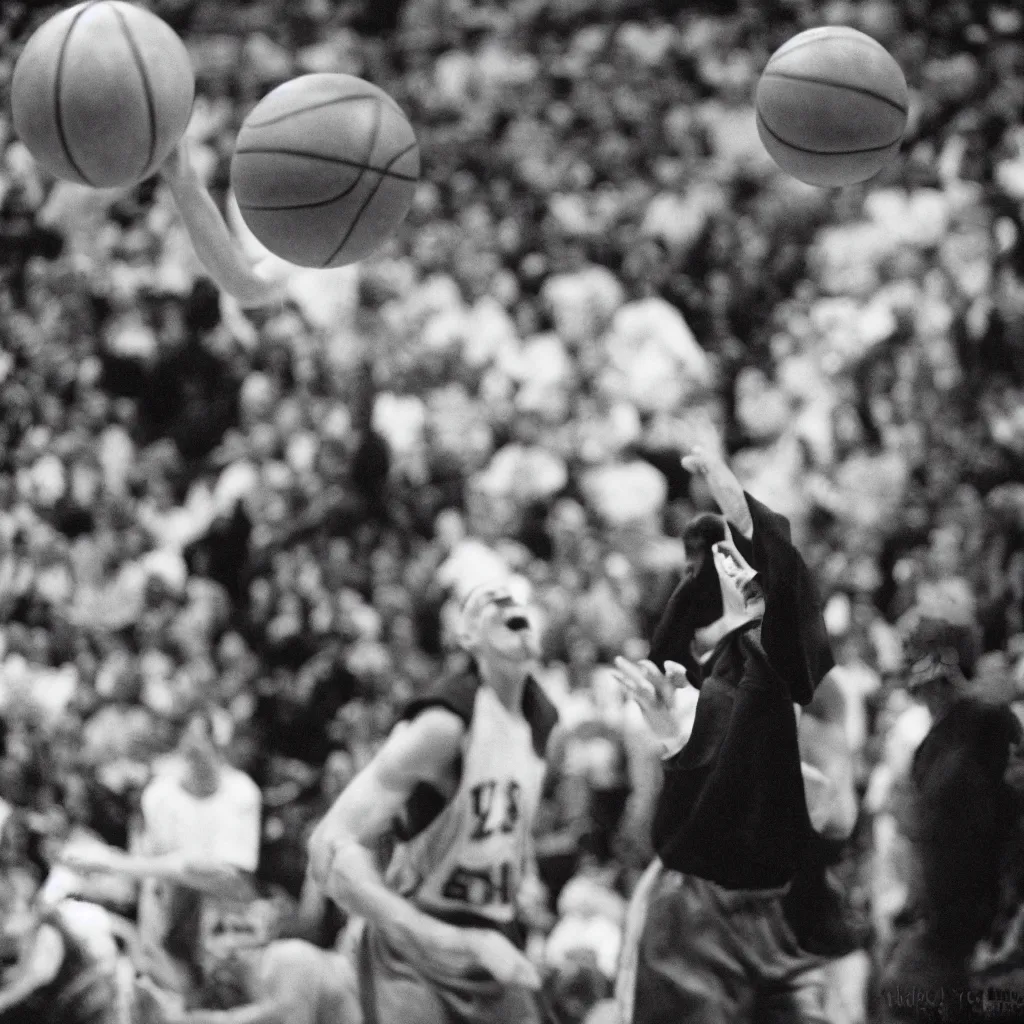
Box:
[309,582,557,1024]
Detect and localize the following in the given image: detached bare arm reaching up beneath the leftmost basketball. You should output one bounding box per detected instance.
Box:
[160,139,285,306]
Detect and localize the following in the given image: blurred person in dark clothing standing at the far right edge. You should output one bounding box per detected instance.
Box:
[879,617,1022,1022]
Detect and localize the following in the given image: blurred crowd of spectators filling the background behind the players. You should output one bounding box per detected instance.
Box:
[0,0,1024,1024]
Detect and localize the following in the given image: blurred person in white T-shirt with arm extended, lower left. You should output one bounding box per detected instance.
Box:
[66,710,261,1001]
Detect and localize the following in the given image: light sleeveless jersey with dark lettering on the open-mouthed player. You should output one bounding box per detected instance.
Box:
[386,685,544,925]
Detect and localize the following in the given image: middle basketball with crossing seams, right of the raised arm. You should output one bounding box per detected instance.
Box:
[231,73,420,267]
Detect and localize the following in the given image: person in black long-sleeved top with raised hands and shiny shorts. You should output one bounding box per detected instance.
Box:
[615,449,837,1024]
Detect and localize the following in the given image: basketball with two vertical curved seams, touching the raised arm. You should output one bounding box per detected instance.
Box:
[11,0,196,188]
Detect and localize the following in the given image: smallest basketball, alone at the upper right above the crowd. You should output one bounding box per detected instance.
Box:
[756,26,908,186]
